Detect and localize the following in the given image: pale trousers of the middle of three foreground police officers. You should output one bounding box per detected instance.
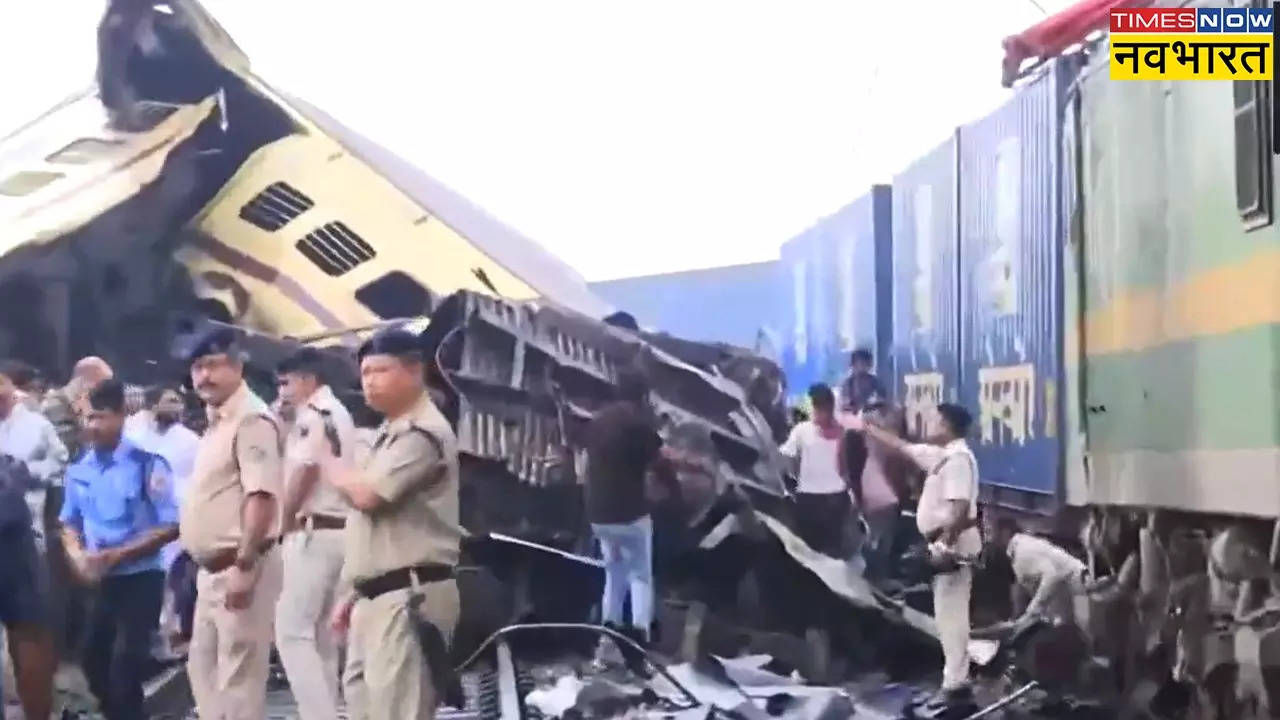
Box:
[275,530,342,720]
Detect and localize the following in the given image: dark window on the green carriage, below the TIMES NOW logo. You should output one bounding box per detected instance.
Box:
[1233,81,1274,229]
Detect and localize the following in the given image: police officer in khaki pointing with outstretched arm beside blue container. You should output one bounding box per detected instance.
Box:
[852,404,982,697]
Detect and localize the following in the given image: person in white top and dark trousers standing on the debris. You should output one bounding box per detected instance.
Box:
[778,383,852,557]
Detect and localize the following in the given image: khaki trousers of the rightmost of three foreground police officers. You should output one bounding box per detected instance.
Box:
[343,580,458,720]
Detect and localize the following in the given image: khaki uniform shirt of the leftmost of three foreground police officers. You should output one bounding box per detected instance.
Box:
[179,383,283,564]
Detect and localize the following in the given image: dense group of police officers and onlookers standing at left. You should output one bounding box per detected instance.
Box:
[0,329,462,720]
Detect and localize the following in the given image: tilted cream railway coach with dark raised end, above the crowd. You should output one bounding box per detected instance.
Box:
[0,0,611,378]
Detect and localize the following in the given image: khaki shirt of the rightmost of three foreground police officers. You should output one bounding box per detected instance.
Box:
[343,393,462,583]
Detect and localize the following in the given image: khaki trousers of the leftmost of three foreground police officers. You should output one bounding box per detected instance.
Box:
[187,550,282,720]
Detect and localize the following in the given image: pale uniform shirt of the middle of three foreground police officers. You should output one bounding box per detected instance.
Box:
[284,386,356,518]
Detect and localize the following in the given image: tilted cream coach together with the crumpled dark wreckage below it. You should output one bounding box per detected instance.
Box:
[0,0,952,671]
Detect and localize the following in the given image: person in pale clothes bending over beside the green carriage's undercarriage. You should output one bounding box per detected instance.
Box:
[992,518,1088,624]
